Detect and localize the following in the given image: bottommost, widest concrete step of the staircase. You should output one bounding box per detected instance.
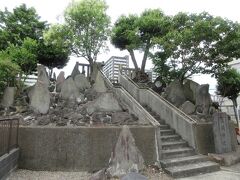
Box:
[164,161,220,178]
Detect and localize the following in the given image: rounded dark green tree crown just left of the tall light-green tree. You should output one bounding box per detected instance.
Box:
[38,24,71,69]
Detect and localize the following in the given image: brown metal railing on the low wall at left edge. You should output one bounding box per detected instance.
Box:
[0,118,19,156]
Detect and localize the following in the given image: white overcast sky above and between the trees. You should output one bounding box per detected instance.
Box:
[0,0,240,93]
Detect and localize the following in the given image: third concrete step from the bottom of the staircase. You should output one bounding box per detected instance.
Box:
[162,147,196,159]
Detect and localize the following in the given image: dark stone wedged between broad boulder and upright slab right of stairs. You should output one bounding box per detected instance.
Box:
[183,79,200,104]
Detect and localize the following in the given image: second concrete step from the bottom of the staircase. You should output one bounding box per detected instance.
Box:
[160,155,208,168]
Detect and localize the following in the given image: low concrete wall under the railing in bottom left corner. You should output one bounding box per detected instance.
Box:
[0,148,19,180]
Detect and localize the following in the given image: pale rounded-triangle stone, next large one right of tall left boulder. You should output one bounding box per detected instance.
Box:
[60,77,80,101]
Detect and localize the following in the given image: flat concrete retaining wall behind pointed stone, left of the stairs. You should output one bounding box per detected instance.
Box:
[19,126,156,172]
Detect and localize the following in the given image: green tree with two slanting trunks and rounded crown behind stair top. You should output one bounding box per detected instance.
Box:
[111,9,171,72]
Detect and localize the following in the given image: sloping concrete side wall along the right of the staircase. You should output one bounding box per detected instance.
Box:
[119,75,215,154]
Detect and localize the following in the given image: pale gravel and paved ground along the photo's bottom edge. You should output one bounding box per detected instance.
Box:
[7,163,240,180]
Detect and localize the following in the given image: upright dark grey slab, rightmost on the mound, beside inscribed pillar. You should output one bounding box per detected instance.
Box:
[196,84,212,115]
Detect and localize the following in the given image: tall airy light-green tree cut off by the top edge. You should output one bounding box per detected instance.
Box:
[65,0,110,64]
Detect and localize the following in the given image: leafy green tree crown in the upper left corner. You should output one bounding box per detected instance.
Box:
[0,4,46,50]
